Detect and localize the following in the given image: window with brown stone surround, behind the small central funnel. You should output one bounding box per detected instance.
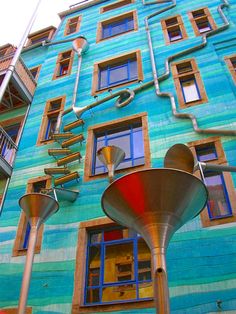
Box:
[84,114,150,180]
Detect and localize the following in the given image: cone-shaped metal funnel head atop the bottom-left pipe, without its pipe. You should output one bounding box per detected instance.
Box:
[19,193,59,227]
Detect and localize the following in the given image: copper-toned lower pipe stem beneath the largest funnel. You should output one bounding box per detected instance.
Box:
[151,248,170,314]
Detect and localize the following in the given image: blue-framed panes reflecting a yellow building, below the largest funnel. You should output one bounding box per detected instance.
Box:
[84,226,153,305]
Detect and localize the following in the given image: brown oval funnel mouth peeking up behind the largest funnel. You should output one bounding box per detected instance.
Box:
[164,144,194,173]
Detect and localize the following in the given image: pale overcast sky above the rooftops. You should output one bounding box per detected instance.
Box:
[0,0,80,46]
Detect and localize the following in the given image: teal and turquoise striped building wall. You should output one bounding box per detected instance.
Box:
[0,0,236,314]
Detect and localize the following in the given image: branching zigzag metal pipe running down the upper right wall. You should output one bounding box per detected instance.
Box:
[145,0,236,136]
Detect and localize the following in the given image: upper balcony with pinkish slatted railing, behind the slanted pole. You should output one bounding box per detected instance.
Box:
[0,53,36,110]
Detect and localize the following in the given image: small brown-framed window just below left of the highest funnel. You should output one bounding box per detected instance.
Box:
[53,50,74,80]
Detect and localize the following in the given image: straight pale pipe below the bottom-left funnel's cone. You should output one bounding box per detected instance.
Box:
[18,224,39,314]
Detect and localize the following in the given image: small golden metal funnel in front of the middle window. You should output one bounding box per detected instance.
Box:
[97,146,125,182]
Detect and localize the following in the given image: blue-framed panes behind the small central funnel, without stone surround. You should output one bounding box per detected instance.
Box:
[92,122,145,175]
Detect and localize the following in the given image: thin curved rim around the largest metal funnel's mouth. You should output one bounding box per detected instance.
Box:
[101,168,209,226]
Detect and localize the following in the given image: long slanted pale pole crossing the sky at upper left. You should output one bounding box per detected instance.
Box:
[0,0,42,103]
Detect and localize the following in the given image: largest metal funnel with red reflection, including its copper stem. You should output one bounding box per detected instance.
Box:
[101,169,208,314]
